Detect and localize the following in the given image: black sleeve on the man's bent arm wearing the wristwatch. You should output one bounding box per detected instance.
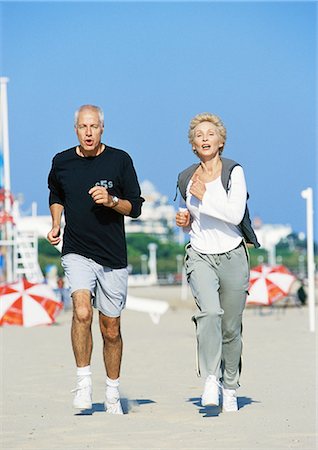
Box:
[122,154,144,219]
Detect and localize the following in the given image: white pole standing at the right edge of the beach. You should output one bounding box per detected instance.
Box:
[301,188,315,332]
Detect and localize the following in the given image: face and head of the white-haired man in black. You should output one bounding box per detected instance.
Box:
[75,108,104,153]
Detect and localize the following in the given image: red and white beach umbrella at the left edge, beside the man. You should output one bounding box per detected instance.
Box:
[0,279,63,327]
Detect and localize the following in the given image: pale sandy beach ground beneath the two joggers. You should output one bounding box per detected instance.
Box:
[1,287,317,450]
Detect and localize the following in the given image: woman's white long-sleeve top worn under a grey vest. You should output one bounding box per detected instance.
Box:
[180,166,247,254]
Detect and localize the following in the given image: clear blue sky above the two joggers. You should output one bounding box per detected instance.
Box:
[0,1,317,236]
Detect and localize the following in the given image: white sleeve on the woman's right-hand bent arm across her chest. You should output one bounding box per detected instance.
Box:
[199,166,247,225]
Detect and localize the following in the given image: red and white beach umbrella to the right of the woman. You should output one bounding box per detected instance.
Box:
[246,264,296,305]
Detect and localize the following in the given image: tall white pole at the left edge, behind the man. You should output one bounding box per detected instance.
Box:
[0,77,13,283]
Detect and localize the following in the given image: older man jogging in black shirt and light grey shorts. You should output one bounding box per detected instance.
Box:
[47,105,143,414]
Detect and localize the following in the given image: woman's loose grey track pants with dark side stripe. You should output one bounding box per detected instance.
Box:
[185,244,249,389]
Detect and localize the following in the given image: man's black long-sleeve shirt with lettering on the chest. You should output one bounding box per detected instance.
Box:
[48,146,143,269]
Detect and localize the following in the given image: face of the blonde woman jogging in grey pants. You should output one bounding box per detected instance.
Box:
[192,121,223,160]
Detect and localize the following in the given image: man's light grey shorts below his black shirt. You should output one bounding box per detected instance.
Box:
[61,253,128,317]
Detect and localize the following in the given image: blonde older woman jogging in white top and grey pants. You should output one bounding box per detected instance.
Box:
[176,113,259,411]
